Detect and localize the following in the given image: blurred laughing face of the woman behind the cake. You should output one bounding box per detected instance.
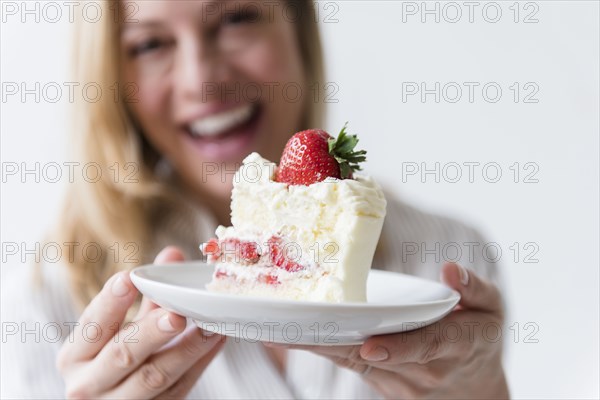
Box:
[121,0,307,204]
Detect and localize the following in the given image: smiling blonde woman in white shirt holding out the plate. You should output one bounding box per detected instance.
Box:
[5,1,508,398]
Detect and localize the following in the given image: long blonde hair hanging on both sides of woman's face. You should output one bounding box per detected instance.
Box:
[52,0,324,307]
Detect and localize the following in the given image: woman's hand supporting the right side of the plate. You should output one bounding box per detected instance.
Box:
[270,264,509,399]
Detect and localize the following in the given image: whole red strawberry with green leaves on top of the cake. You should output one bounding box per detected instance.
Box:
[276,125,366,185]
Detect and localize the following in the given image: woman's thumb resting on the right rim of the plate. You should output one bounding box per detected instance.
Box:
[441,263,502,312]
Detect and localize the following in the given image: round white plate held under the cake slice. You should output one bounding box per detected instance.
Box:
[131,262,460,345]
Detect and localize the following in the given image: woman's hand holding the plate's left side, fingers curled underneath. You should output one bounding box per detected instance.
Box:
[56,247,224,399]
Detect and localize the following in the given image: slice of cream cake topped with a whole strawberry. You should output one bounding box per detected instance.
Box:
[200,127,386,303]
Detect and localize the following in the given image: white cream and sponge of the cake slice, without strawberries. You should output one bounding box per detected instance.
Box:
[210,153,386,302]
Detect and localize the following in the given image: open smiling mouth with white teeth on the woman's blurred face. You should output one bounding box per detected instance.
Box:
[185,104,258,141]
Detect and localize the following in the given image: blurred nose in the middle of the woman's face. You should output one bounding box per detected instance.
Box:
[175,40,230,103]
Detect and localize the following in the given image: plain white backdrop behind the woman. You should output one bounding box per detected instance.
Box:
[1,1,599,398]
